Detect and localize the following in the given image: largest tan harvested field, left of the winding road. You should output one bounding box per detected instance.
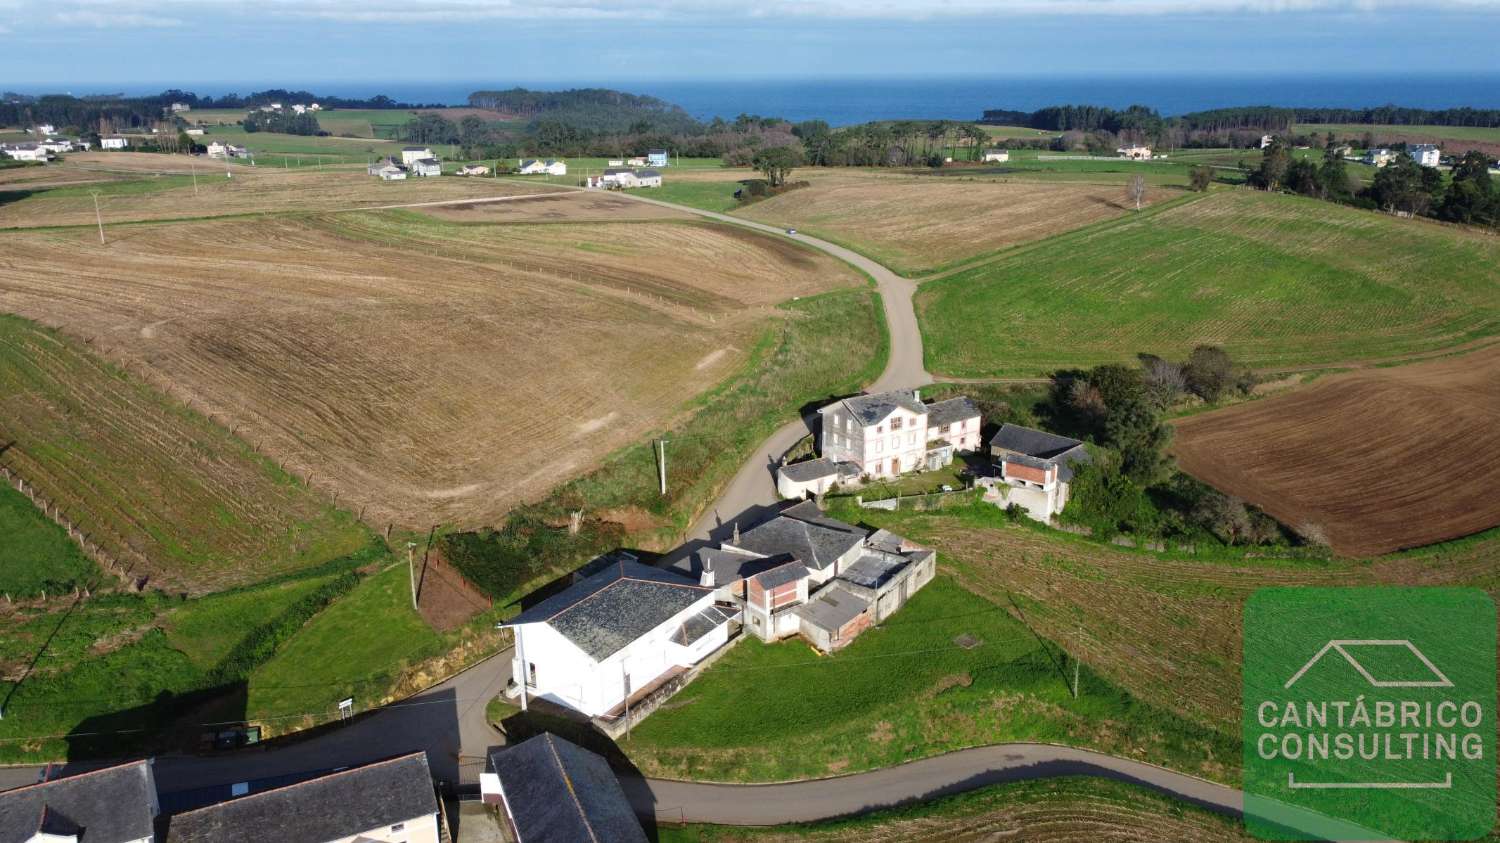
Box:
[0,212,861,528]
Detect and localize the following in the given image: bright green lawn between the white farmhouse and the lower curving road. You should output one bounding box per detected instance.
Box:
[621,575,1233,782]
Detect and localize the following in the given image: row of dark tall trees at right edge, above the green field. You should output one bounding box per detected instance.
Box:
[1248,135,1500,227]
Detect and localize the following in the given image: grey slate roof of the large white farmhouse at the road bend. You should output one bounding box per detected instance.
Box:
[506,561,713,662]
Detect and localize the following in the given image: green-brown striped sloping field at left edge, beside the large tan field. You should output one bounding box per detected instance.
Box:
[0,315,371,593]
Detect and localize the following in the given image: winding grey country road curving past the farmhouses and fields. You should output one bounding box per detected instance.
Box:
[0,182,1266,825]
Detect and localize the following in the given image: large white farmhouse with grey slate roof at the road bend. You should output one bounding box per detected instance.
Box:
[504,558,729,717]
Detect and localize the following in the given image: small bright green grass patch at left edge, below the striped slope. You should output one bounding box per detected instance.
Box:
[0,480,99,597]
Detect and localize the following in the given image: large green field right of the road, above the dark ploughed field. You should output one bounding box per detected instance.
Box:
[917,191,1500,378]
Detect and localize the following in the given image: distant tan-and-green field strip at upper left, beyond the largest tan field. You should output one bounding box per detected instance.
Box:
[0,153,555,228]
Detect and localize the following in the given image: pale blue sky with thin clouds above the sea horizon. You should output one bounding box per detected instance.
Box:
[0,0,1500,93]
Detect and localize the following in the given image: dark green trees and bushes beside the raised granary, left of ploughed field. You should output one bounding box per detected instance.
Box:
[1043,345,1287,545]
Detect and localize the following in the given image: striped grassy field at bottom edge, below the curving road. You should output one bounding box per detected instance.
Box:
[657,777,1250,843]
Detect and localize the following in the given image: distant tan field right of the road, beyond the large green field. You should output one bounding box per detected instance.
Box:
[726,170,1161,273]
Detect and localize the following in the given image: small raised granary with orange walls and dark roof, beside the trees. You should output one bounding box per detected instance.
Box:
[986,425,1089,522]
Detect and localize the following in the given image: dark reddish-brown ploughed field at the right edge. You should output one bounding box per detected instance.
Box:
[1173,348,1500,557]
